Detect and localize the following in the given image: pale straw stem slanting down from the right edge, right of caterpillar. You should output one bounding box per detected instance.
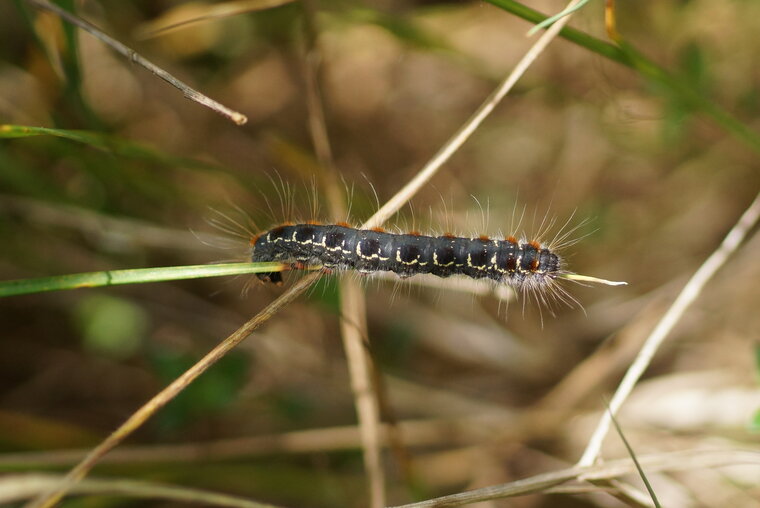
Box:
[578,194,760,466]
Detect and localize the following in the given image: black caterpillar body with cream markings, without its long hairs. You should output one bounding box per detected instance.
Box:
[251,223,565,290]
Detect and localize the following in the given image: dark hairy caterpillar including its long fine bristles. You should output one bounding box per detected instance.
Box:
[209,179,625,306]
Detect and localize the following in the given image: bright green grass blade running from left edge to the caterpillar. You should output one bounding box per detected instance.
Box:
[0,263,287,297]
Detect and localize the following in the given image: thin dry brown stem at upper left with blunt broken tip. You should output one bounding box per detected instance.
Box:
[26,0,248,125]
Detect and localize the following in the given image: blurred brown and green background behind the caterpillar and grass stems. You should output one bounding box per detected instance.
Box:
[0,0,760,507]
